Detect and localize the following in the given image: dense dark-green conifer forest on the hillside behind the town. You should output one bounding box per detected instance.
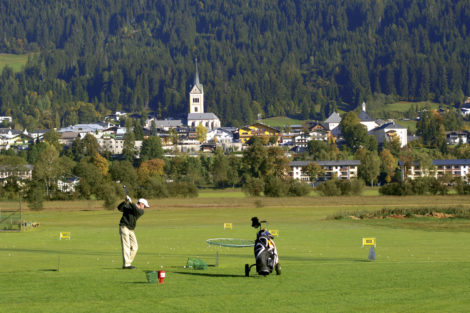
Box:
[0,0,470,129]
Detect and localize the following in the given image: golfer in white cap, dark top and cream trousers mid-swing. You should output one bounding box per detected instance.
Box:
[118,196,149,269]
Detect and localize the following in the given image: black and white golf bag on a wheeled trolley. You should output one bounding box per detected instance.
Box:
[245,217,281,276]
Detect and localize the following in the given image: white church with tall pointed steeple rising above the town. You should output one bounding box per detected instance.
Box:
[187,59,220,130]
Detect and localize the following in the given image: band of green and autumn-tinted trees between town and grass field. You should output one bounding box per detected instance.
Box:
[0,105,470,208]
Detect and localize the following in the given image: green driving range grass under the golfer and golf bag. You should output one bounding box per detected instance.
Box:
[0,193,470,312]
